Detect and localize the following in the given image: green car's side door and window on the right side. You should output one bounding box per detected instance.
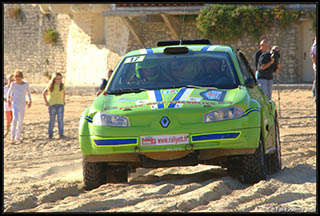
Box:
[237,51,274,149]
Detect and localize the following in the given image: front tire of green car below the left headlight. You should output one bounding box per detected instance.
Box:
[82,158,106,190]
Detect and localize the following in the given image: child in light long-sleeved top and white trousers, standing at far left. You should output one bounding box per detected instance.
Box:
[7,71,31,141]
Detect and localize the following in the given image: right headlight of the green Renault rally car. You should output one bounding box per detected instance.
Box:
[204,107,244,122]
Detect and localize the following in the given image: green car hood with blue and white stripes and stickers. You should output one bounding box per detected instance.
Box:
[94,88,247,116]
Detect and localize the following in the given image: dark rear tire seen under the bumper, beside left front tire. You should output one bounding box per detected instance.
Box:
[106,165,129,183]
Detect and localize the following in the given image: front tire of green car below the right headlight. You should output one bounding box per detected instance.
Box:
[238,134,266,184]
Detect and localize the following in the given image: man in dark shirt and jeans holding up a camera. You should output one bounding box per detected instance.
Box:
[257,45,280,100]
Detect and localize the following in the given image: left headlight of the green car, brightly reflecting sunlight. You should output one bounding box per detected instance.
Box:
[92,112,129,127]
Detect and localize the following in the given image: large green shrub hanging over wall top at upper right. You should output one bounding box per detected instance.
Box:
[196,4,316,41]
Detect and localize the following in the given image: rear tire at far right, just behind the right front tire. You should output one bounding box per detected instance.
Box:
[266,119,282,174]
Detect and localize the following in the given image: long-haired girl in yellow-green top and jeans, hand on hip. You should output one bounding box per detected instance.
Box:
[42,73,66,139]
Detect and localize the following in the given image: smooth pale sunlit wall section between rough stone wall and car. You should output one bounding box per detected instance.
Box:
[66,13,109,85]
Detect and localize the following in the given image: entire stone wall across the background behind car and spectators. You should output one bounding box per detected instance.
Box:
[4,4,310,86]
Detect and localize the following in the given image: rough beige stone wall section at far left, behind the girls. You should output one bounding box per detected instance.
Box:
[4,4,71,83]
